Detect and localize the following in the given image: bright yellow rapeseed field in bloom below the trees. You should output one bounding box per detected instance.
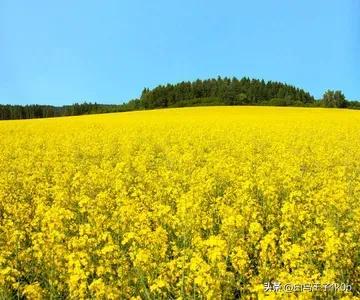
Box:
[0,107,360,299]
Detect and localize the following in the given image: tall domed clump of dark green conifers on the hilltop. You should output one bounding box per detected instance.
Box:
[140,77,315,109]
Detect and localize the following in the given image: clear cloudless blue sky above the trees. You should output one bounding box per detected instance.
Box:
[0,0,360,105]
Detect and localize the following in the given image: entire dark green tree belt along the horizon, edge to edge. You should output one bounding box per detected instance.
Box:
[0,76,360,120]
